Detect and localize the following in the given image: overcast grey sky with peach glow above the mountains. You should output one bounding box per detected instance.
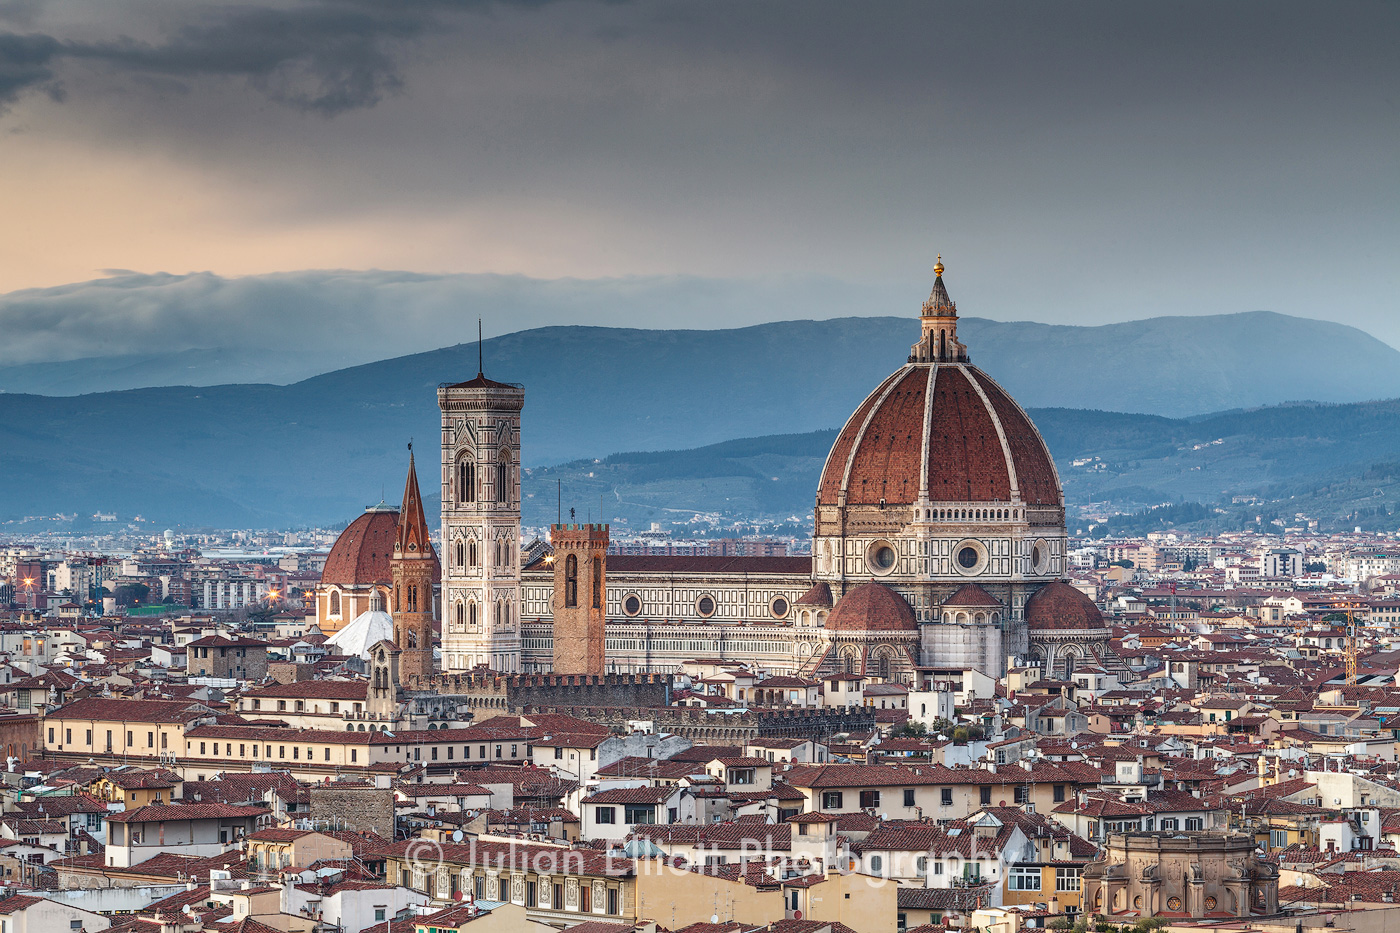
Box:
[0,0,1400,363]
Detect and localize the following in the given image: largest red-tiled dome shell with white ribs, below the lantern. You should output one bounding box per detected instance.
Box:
[818,363,1064,509]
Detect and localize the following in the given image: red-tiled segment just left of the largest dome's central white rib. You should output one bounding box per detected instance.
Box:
[846,367,931,506]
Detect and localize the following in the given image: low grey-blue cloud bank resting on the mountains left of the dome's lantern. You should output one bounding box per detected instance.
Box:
[0,264,896,374]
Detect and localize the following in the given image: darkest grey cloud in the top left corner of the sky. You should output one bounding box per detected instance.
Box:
[0,0,557,115]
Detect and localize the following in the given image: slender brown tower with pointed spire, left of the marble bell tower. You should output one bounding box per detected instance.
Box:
[389,444,441,678]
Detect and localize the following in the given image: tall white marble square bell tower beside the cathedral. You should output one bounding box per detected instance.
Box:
[436,371,525,674]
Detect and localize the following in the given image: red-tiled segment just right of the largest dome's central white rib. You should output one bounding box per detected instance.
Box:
[928,366,1011,502]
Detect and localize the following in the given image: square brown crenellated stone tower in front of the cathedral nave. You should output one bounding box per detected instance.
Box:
[549,524,608,674]
